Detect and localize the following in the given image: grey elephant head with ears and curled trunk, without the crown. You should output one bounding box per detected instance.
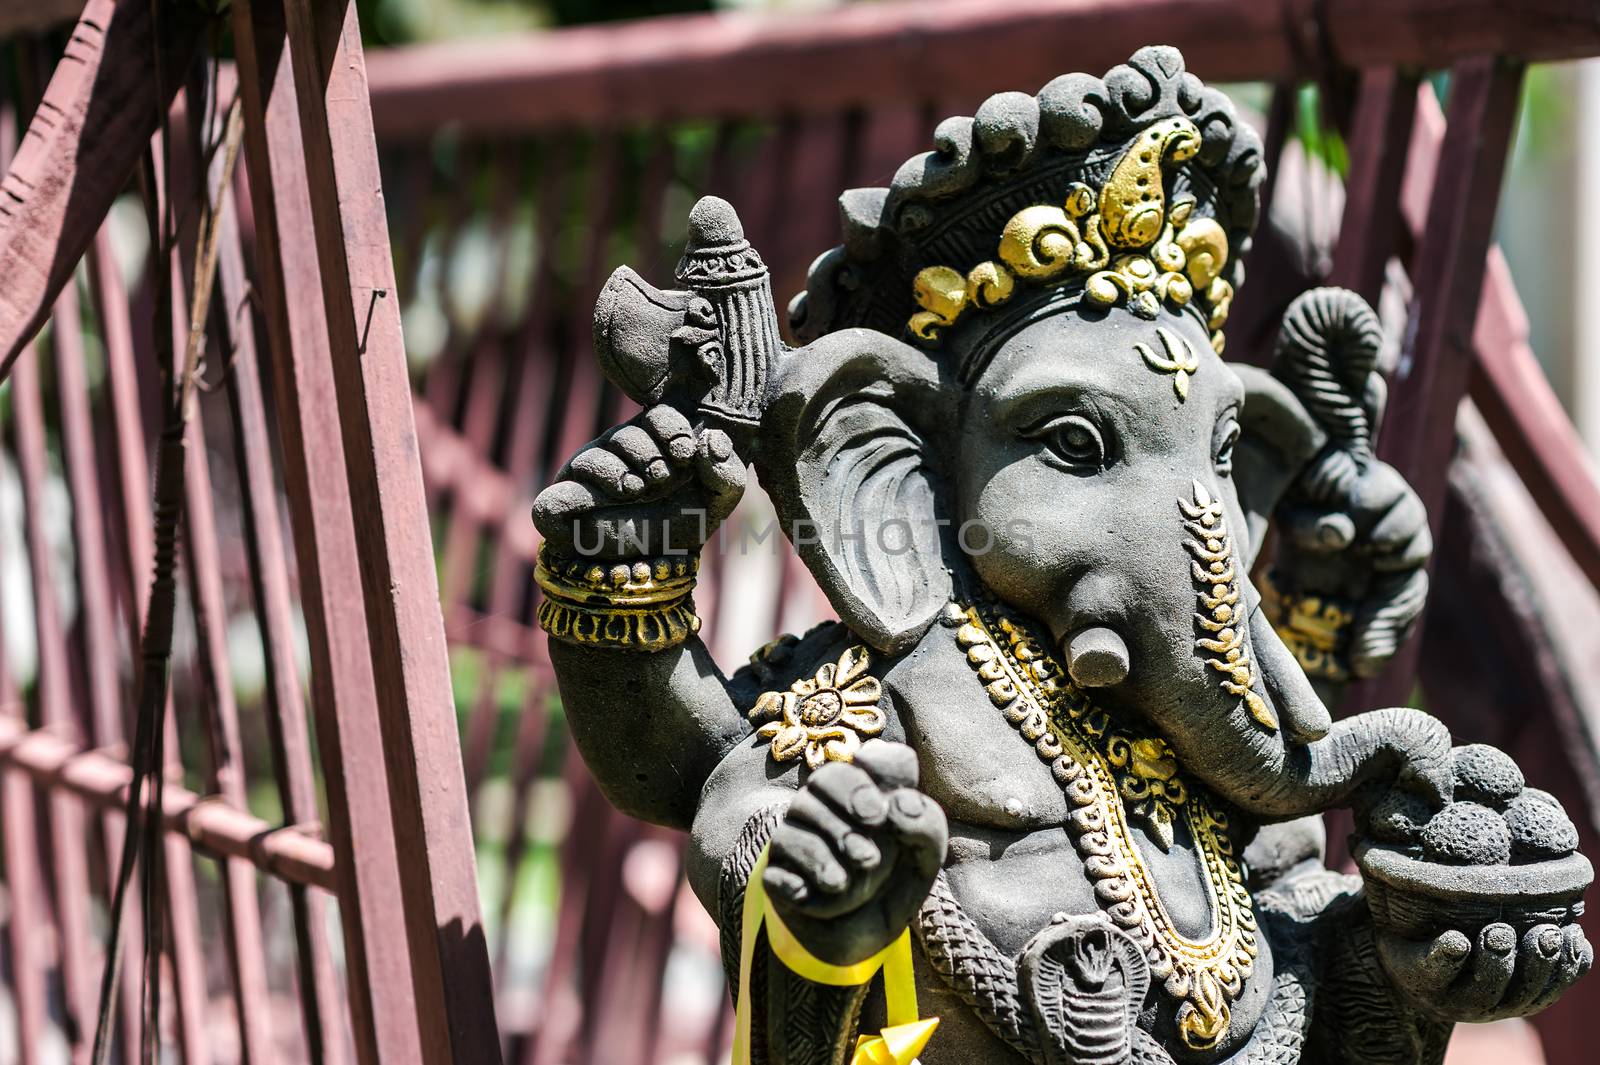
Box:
[757,289,1450,819]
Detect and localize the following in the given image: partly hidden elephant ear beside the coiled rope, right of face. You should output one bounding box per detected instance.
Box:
[1230,363,1328,564]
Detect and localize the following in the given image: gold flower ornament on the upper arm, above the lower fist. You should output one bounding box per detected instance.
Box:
[750,644,886,769]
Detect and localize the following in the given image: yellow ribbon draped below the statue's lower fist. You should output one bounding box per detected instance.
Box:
[733,849,939,1065]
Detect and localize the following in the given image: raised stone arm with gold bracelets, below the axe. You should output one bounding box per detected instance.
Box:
[533,405,750,828]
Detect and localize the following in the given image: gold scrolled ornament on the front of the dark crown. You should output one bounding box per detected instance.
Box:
[907,117,1234,353]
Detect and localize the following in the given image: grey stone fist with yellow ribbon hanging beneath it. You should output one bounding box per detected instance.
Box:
[763,740,947,964]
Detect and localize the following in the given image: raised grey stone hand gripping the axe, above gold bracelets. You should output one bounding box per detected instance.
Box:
[533,405,746,560]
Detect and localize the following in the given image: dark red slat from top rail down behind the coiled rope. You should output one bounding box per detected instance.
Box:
[1328,67,1418,305]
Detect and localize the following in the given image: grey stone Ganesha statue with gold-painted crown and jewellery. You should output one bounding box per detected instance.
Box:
[534,48,1594,1065]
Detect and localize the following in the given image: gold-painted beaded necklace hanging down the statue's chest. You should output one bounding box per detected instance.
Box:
[950,591,1259,1051]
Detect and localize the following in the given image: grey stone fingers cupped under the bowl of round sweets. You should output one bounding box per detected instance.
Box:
[1378,923,1595,1022]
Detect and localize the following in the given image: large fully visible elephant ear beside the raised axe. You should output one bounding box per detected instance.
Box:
[757,329,955,654]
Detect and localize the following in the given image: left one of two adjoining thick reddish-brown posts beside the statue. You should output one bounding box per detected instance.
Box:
[234,0,426,1065]
